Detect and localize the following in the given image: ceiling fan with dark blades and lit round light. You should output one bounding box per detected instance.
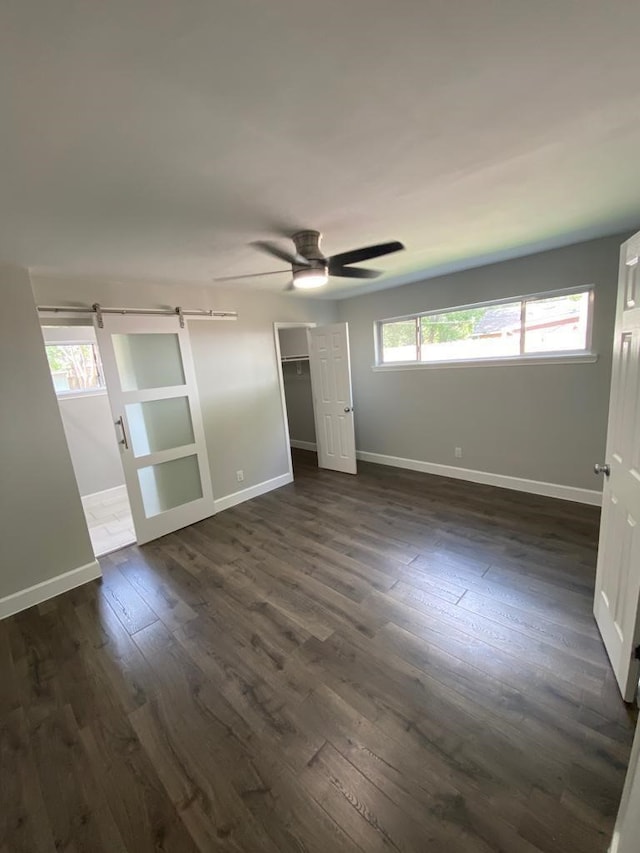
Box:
[215,231,404,290]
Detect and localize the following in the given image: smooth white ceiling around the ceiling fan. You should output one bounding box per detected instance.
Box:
[0,0,640,297]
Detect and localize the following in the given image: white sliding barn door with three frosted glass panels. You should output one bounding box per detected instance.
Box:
[96,314,213,543]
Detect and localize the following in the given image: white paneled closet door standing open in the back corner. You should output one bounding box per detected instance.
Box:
[307,323,357,474]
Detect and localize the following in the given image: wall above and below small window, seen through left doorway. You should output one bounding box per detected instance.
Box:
[42,326,124,497]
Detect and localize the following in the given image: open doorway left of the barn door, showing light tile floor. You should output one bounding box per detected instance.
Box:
[42,321,136,557]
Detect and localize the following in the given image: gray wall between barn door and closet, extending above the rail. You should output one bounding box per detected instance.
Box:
[34,277,336,499]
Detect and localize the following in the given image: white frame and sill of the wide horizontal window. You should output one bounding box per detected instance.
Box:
[372,284,598,371]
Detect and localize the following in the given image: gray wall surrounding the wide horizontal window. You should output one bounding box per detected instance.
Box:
[338,234,627,489]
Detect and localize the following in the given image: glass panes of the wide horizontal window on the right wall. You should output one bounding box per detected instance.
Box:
[376,287,593,365]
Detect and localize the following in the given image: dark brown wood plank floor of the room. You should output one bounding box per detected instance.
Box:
[0,452,634,853]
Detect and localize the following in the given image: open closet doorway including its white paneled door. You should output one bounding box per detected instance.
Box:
[274,323,357,475]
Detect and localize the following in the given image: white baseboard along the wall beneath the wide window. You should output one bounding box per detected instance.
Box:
[356,450,602,506]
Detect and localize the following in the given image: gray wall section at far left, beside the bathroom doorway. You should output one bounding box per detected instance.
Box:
[0,266,94,598]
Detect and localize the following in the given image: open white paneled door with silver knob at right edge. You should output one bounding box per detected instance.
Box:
[594,233,640,702]
